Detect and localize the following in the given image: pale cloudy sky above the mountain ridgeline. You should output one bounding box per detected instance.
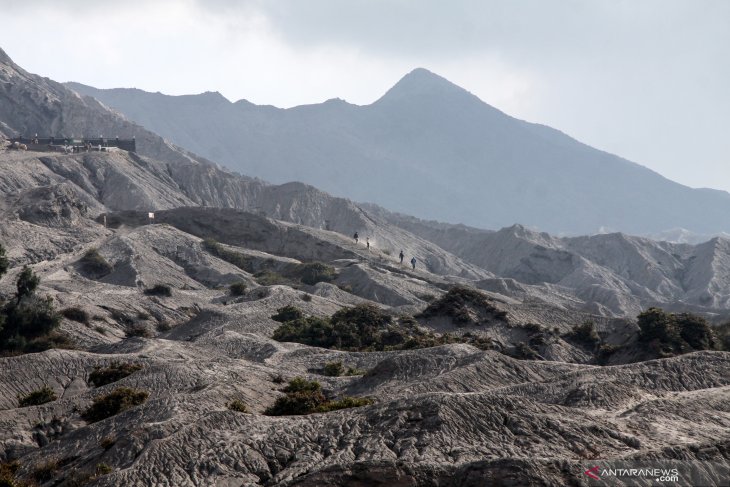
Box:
[0,0,730,193]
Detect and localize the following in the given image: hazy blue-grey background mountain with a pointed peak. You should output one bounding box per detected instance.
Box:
[67,69,730,234]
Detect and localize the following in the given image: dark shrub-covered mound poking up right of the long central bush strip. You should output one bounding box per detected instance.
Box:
[420,286,507,325]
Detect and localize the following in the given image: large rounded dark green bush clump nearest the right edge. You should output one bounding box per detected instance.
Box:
[637,308,722,357]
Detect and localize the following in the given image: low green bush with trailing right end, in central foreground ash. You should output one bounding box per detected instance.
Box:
[264,377,373,416]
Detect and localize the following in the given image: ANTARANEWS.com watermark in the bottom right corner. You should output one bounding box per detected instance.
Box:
[580,460,730,487]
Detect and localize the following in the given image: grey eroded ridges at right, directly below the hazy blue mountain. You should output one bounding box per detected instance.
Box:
[363,205,730,318]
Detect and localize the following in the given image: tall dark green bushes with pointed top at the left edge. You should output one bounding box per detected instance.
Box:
[0,266,63,353]
